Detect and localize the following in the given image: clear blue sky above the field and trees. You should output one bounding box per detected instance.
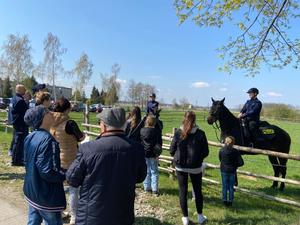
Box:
[0,0,300,107]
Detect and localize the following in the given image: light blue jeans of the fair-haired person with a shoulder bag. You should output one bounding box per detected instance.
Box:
[144,158,159,191]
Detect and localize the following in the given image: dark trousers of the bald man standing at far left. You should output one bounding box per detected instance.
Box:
[11,127,28,166]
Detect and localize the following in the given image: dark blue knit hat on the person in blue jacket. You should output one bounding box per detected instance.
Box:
[24,105,49,129]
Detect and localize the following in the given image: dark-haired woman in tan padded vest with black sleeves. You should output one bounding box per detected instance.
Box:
[51,98,84,224]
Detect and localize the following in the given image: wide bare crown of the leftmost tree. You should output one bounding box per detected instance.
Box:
[0,34,33,82]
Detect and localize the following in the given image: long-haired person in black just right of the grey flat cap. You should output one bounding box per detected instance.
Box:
[125,106,145,142]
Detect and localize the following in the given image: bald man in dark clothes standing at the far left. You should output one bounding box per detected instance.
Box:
[9,84,28,166]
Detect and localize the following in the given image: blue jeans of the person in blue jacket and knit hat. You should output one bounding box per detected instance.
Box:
[27,205,63,225]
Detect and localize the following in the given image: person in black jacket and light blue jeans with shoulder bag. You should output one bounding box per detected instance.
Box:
[141,116,162,196]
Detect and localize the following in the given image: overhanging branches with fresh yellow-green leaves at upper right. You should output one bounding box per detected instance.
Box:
[174,0,300,75]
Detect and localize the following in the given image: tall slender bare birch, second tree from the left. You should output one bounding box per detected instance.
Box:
[43,33,67,101]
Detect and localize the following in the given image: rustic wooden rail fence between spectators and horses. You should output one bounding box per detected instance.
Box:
[82,123,300,207]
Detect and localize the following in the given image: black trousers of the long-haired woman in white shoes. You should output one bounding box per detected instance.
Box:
[176,171,203,217]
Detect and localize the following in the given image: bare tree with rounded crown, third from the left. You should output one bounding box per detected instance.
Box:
[72,53,93,94]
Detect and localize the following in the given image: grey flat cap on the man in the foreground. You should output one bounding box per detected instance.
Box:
[96,108,126,128]
